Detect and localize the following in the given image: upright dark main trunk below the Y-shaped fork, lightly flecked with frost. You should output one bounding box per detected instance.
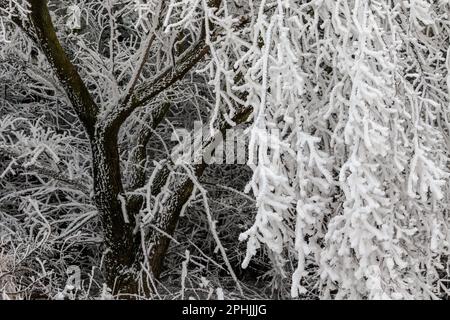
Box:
[91,126,139,294]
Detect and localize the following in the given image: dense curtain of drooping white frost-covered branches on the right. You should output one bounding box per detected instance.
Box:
[236,1,449,298]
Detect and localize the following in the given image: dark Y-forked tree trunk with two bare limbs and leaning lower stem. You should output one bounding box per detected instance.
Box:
[25,0,232,295]
